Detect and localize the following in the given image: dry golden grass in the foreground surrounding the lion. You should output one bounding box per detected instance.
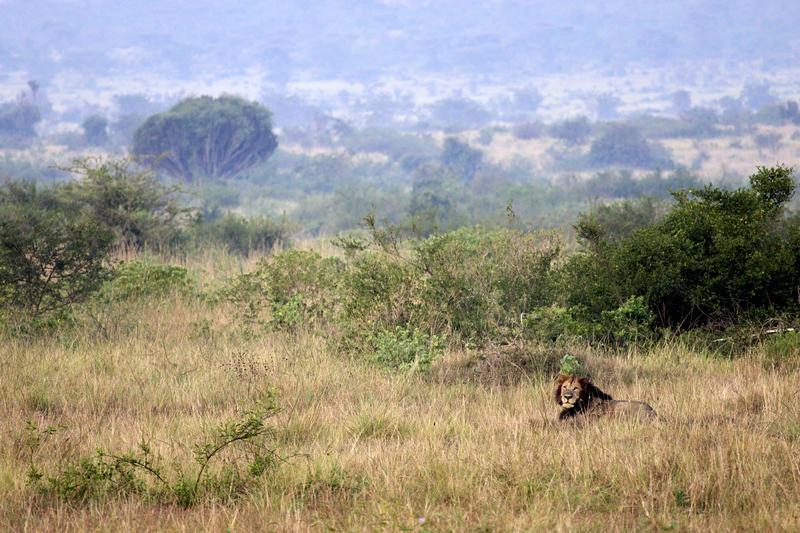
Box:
[0,260,800,531]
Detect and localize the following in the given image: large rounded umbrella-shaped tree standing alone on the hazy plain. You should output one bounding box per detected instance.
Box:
[133,96,278,182]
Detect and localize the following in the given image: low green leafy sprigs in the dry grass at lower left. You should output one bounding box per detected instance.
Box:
[26,391,279,507]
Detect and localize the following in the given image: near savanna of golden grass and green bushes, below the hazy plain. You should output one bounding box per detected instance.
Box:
[0,155,800,531]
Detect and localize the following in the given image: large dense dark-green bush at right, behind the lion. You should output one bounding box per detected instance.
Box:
[563,167,800,329]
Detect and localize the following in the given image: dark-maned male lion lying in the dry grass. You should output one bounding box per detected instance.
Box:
[553,374,656,420]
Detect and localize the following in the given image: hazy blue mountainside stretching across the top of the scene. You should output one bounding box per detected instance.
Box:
[0,0,800,83]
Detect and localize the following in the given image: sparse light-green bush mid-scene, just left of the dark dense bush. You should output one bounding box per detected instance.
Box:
[343,223,560,341]
